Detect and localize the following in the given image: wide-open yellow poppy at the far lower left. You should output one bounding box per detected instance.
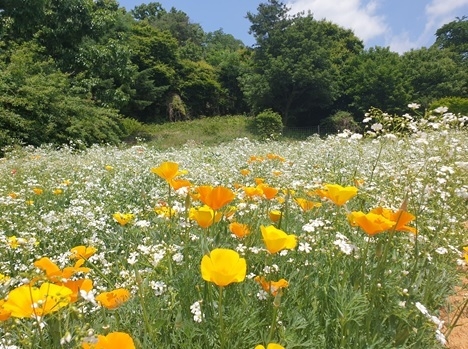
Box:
[3,282,72,318]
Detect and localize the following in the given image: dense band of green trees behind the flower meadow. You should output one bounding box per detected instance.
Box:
[0,0,468,148]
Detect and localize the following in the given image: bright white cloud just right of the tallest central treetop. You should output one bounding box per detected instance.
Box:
[287,0,388,42]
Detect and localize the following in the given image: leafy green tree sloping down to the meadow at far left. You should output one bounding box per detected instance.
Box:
[0,43,123,152]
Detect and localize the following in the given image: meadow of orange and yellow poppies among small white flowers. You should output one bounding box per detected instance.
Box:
[0,124,468,349]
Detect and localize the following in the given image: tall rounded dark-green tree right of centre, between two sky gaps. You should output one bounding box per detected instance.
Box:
[241,0,363,125]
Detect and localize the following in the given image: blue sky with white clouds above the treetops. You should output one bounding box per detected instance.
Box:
[119,0,468,53]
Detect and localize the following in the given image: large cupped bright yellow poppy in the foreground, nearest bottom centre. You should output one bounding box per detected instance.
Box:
[201,248,247,286]
